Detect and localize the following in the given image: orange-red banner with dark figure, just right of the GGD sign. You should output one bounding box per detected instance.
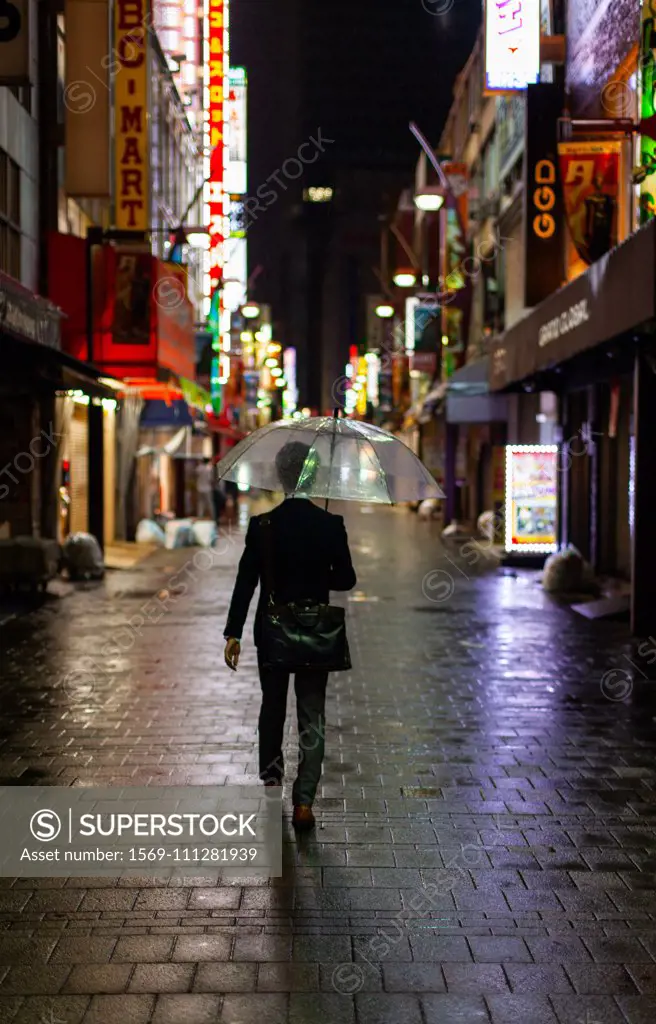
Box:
[558,141,624,264]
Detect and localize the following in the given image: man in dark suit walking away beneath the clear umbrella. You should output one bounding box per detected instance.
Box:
[224,441,356,829]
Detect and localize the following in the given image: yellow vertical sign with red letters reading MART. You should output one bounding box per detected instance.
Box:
[114,0,150,231]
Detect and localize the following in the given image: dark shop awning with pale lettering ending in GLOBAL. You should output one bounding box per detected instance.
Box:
[489,220,656,391]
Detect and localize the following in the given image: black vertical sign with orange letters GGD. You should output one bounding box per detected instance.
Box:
[524,84,565,308]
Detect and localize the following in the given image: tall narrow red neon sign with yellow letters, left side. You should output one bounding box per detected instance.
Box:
[208,0,226,291]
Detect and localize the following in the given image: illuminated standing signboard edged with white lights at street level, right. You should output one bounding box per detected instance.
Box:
[506,444,558,554]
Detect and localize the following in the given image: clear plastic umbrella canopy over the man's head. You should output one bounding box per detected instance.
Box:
[217,416,444,505]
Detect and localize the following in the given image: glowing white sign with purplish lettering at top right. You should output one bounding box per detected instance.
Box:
[485,0,540,93]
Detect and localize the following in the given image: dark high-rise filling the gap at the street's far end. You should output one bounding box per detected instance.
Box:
[231,0,480,409]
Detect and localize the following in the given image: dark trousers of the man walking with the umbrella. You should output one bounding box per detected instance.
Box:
[258,664,327,806]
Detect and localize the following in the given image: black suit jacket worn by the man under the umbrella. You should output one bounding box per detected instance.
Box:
[223,498,356,644]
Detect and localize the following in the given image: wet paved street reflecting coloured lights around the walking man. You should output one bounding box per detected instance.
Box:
[0,508,656,1024]
